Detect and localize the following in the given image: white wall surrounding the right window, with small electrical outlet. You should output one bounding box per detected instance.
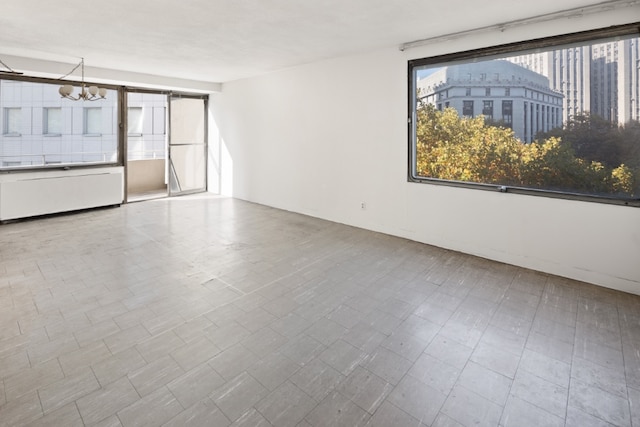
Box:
[209,9,640,294]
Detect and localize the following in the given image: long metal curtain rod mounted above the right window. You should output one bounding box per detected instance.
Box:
[400,0,640,52]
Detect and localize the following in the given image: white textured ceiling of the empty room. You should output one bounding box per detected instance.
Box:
[0,0,636,82]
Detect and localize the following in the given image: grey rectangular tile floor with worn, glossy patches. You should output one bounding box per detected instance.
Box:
[0,195,640,427]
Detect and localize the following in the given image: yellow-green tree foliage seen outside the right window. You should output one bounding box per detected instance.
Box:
[416,103,640,196]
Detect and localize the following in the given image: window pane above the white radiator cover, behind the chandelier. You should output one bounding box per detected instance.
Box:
[0,78,118,170]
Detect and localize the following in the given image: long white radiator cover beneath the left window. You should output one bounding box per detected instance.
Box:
[0,166,124,221]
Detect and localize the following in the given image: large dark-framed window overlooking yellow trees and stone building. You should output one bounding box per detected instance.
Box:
[409,25,640,206]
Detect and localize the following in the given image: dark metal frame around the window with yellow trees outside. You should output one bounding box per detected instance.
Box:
[407,22,640,207]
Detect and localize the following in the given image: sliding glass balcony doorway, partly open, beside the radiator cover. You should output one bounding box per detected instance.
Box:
[125,92,207,202]
